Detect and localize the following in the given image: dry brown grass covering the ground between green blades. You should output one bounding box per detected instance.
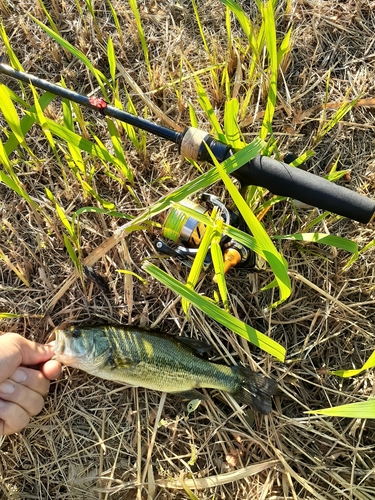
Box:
[0,0,375,500]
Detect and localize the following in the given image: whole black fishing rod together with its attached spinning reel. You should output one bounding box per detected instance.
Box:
[0,63,375,269]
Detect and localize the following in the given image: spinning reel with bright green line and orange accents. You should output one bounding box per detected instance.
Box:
[155,193,256,273]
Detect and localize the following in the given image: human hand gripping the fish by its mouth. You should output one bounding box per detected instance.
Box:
[0,333,61,436]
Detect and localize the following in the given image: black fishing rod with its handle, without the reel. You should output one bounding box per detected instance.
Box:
[0,63,375,224]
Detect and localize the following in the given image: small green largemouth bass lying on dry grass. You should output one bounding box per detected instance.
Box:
[54,326,277,414]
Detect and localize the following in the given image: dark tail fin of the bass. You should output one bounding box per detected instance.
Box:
[231,366,277,415]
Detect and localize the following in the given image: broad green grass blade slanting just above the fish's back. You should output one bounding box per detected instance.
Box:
[142,262,285,361]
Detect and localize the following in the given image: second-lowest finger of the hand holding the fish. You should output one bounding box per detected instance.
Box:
[0,379,44,418]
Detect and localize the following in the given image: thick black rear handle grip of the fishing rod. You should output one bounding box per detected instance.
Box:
[231,156,375,224]
